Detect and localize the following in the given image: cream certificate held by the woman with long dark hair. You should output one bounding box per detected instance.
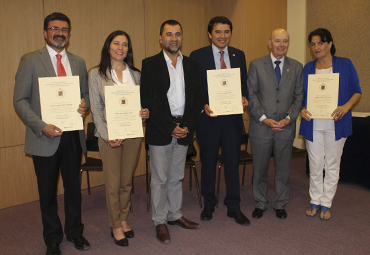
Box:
[105,86,144,140]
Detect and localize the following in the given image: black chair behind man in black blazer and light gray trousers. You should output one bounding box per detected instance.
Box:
[145,143,202,212]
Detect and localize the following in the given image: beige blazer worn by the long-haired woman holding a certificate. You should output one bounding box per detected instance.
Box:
[89,65,140,141]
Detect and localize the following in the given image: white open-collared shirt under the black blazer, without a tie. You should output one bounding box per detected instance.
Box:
[163,51,185,117]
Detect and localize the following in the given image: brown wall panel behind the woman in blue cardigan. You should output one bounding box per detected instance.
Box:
[306,0,370,112]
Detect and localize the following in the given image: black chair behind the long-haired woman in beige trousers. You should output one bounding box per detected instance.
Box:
[80,122,134,212]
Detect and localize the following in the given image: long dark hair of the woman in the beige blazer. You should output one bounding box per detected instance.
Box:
[97,30,140,80]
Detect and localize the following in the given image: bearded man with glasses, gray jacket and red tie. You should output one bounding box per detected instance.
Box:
[13,12,90,254]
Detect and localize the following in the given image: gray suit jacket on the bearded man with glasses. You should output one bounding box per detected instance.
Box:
[13,47,90,157]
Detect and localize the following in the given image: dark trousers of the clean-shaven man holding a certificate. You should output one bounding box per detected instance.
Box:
[197,115,242,212]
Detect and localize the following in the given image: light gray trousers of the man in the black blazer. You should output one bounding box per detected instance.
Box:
[149,138,188,226]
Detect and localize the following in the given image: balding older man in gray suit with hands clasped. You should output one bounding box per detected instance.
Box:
[247,28,303,219]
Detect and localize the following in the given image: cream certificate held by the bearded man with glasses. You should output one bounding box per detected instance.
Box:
[39,76,83,131]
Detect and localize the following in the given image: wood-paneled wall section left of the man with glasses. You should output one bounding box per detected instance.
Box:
[0,0,44,209]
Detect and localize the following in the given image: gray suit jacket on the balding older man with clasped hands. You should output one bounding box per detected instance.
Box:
[247,54,303,140]
